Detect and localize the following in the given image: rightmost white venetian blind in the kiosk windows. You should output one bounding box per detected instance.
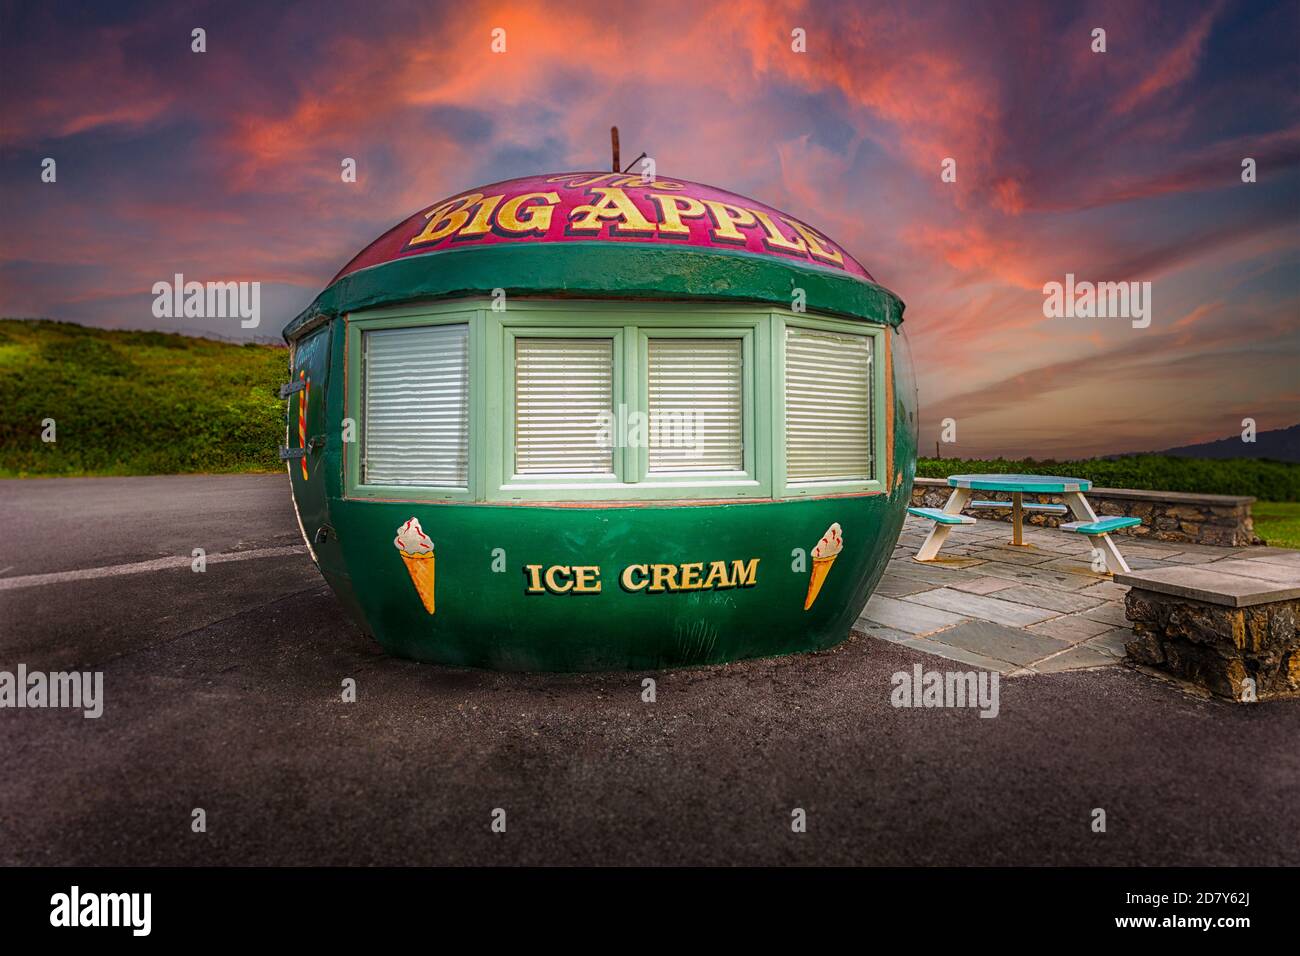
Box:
[785,326,872,483]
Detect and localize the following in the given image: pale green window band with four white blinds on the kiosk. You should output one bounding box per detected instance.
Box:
[348,303,891,503]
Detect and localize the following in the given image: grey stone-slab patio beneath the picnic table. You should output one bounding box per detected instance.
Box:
[854,515,1295,676]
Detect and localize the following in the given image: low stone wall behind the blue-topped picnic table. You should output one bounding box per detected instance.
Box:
[911,479,1262,548]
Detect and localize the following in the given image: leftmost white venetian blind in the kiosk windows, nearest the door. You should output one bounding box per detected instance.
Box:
[361,325,469,488]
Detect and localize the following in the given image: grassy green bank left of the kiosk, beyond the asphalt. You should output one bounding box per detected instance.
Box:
[0,319,289,477]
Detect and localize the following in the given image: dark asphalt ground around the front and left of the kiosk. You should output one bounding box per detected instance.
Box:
[0,475,1300,865]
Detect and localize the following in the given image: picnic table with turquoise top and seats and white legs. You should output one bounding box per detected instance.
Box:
[907,475,1141,574]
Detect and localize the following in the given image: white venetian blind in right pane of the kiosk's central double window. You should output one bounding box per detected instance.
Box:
[646,338,745,473]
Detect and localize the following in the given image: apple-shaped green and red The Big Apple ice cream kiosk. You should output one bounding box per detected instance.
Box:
[281,173,917,671]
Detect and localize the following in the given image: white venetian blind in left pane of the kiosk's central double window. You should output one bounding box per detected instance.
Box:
[515,336,614,476]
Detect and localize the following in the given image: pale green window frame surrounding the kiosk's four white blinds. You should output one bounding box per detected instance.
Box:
[345,299,887,502]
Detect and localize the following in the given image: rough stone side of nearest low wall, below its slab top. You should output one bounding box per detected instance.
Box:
[1125,587,1300,700]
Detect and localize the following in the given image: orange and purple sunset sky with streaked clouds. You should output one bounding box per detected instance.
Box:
[0,0,1300,458]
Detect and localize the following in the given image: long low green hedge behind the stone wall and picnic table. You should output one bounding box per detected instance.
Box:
[917,455,1300,501]
